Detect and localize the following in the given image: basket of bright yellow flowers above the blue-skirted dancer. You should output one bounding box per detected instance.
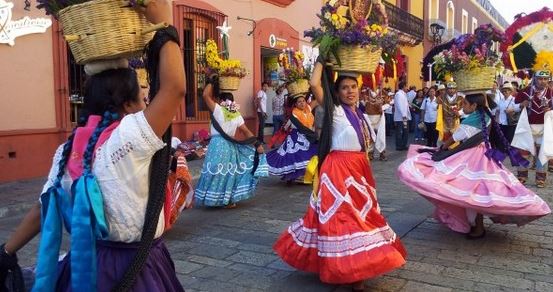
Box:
[205,40,247,91]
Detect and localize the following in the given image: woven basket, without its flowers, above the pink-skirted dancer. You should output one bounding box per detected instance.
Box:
[453,67,496,91]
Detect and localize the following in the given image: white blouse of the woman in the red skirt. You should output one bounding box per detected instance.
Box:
[330,105,376,151]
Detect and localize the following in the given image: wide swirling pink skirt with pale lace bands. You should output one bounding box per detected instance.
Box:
[397,144,551,233]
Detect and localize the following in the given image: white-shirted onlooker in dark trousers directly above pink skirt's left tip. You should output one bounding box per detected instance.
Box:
[394,81,411,151]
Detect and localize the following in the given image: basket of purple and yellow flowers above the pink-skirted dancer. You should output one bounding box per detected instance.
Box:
[434,24,504,91]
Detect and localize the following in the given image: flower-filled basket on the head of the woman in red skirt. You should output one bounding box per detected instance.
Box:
[305,0,395,74]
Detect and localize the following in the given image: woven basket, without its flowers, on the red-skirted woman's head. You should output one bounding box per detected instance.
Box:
[330,45,382,74]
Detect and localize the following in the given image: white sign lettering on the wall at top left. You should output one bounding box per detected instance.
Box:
[0,0,52,46]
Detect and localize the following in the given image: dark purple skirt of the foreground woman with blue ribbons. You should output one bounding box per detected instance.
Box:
[56,238,184,292]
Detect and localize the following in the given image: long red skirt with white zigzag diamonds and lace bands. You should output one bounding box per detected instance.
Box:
[273,151,406,284]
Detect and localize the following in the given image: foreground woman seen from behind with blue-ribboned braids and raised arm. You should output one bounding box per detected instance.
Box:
[0,0,185,291]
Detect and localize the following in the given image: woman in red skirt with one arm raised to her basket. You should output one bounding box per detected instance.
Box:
[274,63,406,291]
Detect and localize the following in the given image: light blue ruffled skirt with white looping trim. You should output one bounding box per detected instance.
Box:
[194,135,268,207]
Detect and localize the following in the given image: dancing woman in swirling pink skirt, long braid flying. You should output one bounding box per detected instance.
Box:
[398,93,551,239]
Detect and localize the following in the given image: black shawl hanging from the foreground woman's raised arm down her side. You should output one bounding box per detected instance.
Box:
[113,26,179,291]
